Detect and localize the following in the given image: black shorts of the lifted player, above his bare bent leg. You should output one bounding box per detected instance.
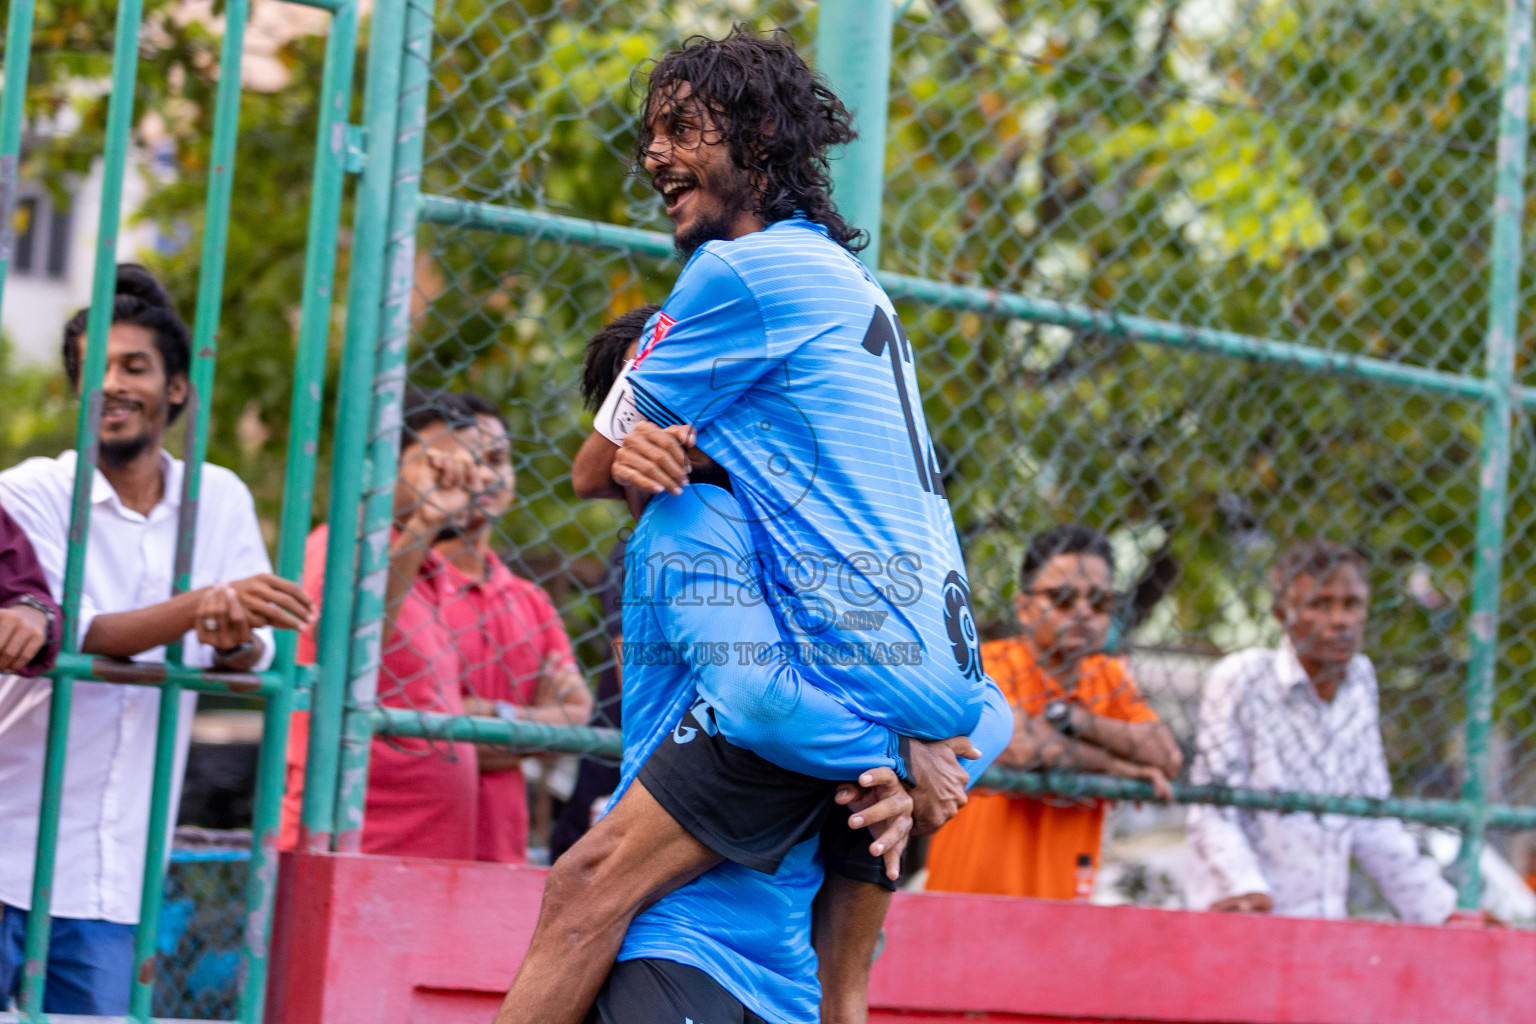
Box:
[639,700,895,892]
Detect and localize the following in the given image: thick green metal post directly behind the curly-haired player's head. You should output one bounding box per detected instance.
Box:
[816,0,891,270]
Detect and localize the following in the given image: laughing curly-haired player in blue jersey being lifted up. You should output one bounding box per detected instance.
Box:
[498,32,1011,1024]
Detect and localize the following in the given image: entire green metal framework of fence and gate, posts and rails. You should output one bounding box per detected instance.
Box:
[9,0,1536,1024]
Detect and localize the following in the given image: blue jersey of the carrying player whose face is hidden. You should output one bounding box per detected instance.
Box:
[610,485,1014,1024]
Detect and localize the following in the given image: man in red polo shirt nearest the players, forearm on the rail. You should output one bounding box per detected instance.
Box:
[433,393,591,864]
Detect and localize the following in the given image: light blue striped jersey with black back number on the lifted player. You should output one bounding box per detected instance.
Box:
[628,216,986,740]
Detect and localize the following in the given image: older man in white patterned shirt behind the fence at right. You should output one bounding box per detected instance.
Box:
[1189,540,1456,924]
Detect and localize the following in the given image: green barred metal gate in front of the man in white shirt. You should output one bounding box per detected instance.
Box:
[0,0,358,1024]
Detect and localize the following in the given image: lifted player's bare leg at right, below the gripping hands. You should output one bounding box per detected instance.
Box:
[811,874,891,1024]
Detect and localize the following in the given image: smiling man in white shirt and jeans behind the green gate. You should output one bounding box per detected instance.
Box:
[0,264,312,1016]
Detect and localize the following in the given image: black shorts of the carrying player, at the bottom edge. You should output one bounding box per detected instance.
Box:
[587,960,768,1024]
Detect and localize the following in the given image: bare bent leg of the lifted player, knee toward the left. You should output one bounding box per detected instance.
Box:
[496,781,720,1024]
